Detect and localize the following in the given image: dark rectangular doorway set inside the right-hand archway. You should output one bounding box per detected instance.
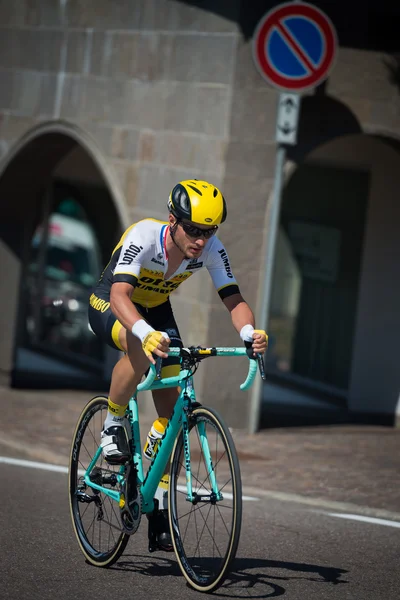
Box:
[266,165,369,405]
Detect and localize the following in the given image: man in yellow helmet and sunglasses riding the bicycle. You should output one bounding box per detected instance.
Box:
[89,179,267,549]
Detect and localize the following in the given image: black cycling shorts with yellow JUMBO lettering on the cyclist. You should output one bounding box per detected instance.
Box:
[89,290,183,377]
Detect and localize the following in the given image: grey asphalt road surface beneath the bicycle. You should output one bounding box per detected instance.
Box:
[0,462,400,600]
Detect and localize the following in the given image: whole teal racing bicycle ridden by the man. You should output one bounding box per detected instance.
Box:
[69,343,265,592]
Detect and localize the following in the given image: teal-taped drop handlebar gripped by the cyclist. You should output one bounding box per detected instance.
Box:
[137,347,265,391]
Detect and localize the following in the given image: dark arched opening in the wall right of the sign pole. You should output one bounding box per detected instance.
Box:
[264,134,400,424]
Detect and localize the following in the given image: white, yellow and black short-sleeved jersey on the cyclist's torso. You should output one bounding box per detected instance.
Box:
[95,219,239,310]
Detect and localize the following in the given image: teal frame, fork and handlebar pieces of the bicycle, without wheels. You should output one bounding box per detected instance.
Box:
[84,347,257,513]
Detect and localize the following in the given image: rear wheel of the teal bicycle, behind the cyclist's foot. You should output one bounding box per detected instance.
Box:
[69,396,129,567]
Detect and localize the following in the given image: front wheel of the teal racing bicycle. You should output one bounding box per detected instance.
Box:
[168,406,242,592]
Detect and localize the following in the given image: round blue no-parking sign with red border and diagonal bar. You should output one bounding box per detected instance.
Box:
[253,2,337,92]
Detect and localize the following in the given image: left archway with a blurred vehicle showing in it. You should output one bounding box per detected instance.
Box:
[0,123,127,388]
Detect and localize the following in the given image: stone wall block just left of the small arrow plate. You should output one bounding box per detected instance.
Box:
[231,87,278,143]
